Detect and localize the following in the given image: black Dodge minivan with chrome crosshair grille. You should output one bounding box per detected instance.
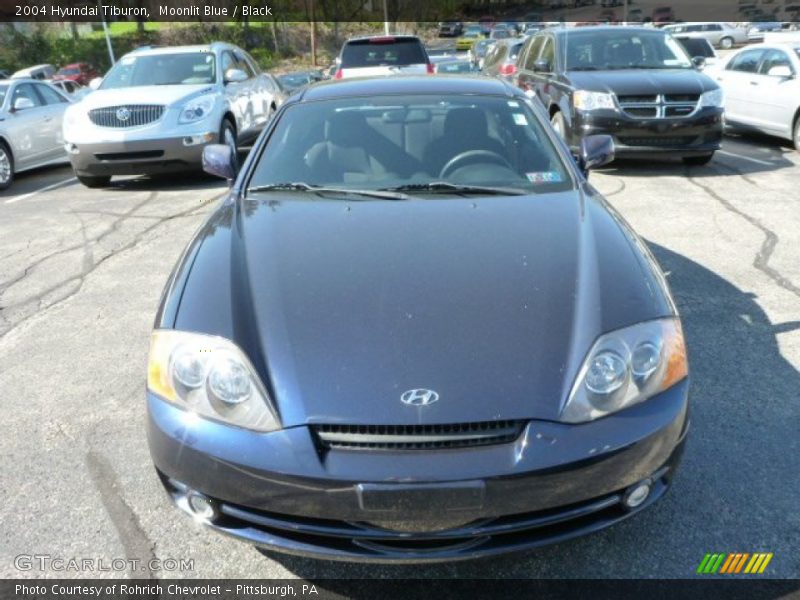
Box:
[514,26,722,165]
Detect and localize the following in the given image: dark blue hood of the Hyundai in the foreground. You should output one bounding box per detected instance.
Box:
[174,192,674,426]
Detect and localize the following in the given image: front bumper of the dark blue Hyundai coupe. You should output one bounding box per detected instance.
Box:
[148,381,688,562]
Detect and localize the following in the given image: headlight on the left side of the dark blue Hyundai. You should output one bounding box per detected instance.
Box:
[147,330,280,431]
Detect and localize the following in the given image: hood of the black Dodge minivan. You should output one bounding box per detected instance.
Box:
[568,69,717,96]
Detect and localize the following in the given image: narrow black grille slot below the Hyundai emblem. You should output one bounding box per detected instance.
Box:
[313,420,526,450]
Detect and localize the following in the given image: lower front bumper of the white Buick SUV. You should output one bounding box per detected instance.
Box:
[67,132,219,176]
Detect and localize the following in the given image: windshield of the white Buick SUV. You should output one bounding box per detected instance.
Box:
[100,52,216,90]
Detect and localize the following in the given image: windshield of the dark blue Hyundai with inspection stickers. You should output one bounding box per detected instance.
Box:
[248,94,574,193]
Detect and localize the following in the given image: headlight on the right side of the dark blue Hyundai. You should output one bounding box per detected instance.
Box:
[561,318,689,423]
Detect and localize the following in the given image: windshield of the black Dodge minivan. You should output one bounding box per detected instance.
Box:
[562,28,692,71]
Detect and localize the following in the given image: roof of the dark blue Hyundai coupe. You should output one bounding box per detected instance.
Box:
[297,75,524,102]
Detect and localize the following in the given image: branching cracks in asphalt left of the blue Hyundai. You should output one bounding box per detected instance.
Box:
[0,192,224,340]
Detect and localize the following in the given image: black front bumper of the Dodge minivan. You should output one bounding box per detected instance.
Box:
[567,108,723,158]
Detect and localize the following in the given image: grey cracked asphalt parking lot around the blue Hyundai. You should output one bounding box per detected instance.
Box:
[0,137,800,578]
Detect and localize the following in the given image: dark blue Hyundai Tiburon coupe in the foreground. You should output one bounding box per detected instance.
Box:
[147,77,688,561]
